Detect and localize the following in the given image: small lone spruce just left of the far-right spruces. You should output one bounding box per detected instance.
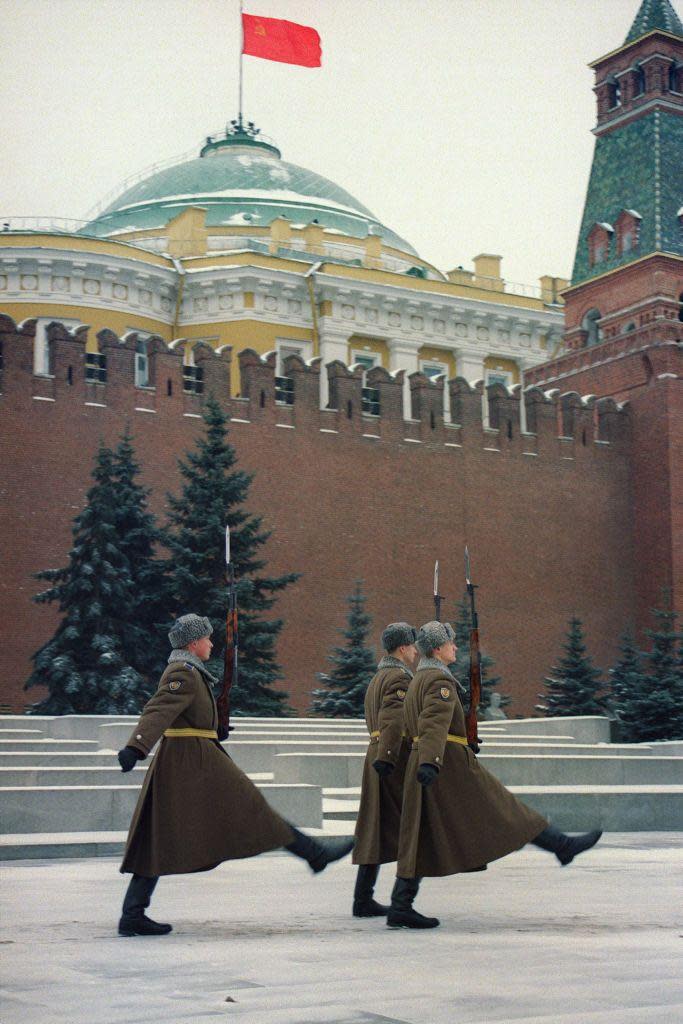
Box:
[536,615,605,718]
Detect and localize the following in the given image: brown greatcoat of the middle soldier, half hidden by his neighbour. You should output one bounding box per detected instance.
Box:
[353,663,411,864]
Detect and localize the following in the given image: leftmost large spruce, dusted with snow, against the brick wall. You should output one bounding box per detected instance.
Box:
[25,443,148,715]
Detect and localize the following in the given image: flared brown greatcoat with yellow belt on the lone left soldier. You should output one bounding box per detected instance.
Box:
[121,662,294,877]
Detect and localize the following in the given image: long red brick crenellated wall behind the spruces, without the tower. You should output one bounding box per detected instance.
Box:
[0,316,637,715]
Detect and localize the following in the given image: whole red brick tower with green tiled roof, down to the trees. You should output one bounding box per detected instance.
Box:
[525,0,683,630]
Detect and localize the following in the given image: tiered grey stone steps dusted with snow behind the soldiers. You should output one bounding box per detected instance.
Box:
[0,716,683,859]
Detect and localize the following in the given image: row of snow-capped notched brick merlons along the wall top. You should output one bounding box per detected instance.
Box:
[0,316,634,458]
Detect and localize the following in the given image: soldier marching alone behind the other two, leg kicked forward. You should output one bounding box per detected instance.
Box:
[119,614,353,935]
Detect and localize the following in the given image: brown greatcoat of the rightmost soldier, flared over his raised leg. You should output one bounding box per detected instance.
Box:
[397,668,548,879]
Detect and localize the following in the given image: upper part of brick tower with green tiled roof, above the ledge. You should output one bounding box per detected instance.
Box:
[565,0,683,349]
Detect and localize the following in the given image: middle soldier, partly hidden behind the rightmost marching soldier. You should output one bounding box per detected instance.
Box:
[353,623,418,918]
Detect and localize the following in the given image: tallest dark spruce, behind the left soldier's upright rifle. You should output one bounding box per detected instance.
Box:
[165,396,299,715]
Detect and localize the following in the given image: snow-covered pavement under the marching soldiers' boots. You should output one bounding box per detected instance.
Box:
[0,833,683,1024]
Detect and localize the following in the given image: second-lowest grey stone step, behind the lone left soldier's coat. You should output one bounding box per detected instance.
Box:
[0,782,323,834]
